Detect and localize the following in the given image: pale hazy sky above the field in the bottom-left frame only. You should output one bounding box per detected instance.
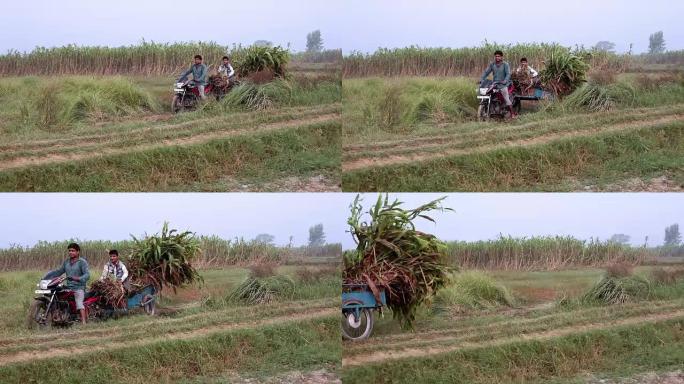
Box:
[0,193,349,247]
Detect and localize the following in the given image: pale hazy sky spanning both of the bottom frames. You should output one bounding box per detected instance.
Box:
[0,193,684,247]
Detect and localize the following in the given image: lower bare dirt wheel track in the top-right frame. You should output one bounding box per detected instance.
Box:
[342,114,684,171]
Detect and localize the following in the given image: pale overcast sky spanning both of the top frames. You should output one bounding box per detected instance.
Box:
[0,0,684,53]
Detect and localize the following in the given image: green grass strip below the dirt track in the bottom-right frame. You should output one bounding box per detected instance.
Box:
[342,320,684,383]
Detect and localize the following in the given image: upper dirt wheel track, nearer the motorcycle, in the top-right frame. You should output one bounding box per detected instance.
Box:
[342,104,684,154]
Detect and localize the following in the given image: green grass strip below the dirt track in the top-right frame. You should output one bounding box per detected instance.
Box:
[342,123,684,192]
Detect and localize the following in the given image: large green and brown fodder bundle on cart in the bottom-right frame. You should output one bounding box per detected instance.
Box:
[343,196,451,328]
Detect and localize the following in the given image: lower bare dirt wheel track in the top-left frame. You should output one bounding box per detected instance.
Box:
[0,113,340,171]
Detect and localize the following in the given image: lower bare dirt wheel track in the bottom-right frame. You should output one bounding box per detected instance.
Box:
[342,310,684,367]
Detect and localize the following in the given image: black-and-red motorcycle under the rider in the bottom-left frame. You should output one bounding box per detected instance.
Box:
[27,277,105,328]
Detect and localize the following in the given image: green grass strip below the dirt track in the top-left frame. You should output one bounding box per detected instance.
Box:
[0,122,340,192]
